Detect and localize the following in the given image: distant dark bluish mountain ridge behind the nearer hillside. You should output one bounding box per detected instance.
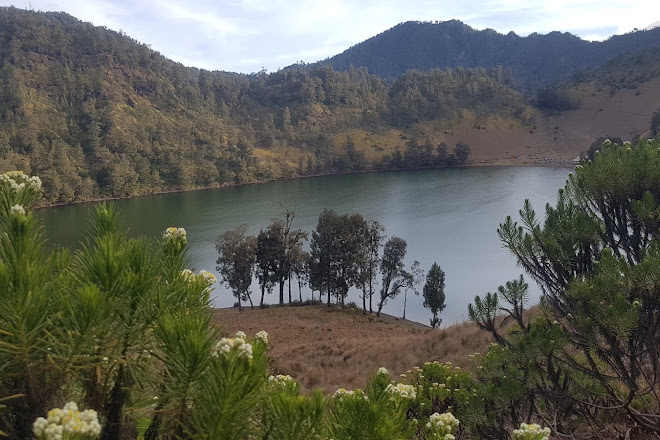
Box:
[320,20,660,91]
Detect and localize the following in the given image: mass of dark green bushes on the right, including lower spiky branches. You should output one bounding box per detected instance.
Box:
[469,140,660,439]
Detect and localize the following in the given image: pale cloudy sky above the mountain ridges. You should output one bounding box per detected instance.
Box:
[0,0,660,73]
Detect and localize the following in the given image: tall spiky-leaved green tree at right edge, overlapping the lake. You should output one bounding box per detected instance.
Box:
[498,141,660,433]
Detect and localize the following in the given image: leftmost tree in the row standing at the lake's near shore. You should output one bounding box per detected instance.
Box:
[215,224,257,308]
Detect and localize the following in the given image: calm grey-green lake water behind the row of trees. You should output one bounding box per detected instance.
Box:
[37,166,571,325]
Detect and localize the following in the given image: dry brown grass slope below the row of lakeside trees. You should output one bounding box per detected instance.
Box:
[215,305,491,392]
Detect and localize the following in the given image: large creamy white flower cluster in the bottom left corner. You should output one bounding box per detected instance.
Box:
[32,402,101,440]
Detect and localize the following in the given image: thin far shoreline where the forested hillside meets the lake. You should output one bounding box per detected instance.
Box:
[33,159,575,210]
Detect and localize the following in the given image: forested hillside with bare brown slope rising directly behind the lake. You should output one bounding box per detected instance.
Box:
[0,7,660,204]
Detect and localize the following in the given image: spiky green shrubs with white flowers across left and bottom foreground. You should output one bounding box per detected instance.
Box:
[0,171,524,440]
